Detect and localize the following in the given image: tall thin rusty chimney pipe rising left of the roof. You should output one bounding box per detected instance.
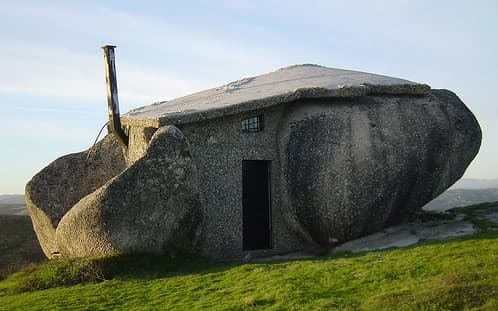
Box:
[102,45,128,150]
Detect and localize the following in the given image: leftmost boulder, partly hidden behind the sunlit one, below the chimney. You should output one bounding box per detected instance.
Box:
[25,135,126,258]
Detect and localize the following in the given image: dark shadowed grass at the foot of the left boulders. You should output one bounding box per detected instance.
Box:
[7,254,239,294]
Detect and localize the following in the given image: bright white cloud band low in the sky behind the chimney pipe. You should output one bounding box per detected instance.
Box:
[0,42,198,105]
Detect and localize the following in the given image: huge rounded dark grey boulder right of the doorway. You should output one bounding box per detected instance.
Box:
[279,90,481,247]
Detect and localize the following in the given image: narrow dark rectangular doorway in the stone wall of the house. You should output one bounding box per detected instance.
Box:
[242,160,271,251]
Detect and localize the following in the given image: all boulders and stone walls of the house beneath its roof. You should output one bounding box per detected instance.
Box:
[26,90,481,259]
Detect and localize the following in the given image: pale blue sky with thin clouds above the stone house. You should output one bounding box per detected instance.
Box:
[0,0,498,193]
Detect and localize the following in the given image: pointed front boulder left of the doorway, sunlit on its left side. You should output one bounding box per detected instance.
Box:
[56,126,201,257]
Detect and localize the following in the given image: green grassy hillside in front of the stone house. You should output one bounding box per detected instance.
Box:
[0,204,498,310]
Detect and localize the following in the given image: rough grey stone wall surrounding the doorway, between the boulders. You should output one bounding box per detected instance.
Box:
[179,106,303,259]
